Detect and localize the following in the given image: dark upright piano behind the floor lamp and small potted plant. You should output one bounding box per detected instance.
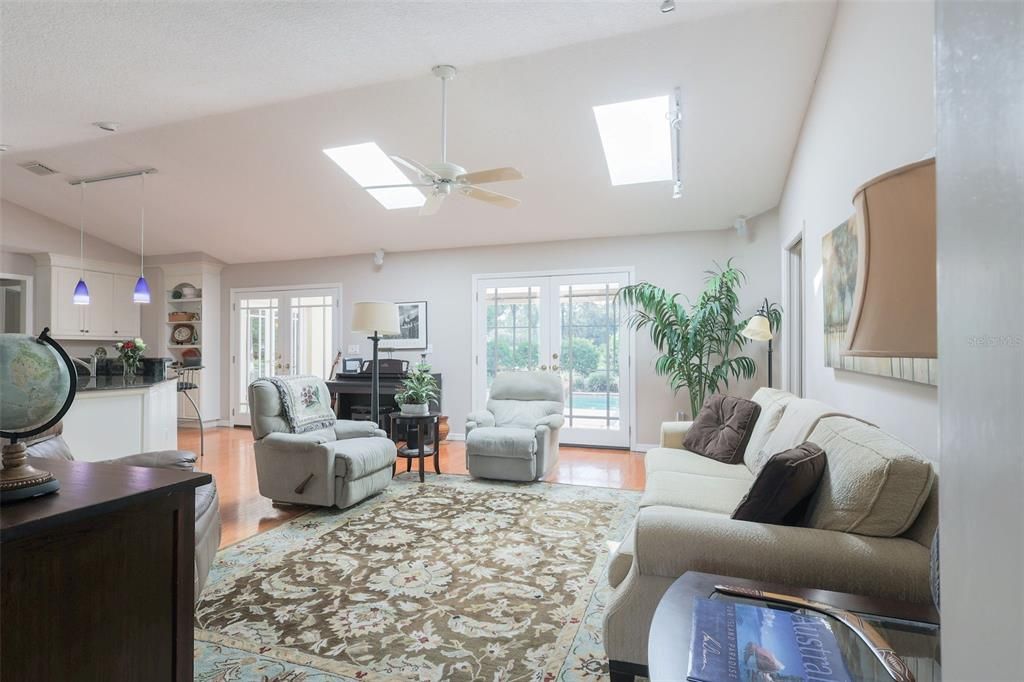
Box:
[327,358,441,439]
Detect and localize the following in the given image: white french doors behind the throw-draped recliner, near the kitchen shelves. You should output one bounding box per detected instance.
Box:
[231,287,341,424]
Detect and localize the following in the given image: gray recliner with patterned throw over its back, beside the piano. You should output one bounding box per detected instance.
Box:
[249,379,397,509]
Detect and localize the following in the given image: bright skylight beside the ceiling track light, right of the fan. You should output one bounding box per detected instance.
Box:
[594,95,672,184]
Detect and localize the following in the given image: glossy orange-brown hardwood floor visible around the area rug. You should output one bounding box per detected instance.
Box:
[178,427,644,547]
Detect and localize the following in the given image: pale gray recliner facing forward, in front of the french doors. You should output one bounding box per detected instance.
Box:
[466,372,565,480]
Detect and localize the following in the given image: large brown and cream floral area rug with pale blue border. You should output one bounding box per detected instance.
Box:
[195,474,639,682]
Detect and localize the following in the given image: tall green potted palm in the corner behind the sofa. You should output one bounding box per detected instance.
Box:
[618,259,782,416]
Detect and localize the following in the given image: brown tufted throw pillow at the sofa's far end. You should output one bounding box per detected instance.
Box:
[683,395,761,464]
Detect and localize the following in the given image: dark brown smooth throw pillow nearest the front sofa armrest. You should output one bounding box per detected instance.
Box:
[732,440,825,525]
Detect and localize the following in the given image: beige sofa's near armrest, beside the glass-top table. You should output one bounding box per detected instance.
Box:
[634,506,931,603]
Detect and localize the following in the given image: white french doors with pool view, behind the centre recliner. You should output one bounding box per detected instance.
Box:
[474,271,632,447]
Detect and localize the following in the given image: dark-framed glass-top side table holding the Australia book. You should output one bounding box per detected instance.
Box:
[647,572,942,682]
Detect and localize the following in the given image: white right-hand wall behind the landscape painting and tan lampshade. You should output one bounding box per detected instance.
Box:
[777,1,942,459]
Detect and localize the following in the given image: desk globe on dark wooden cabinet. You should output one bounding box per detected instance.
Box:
[0,328,78,503]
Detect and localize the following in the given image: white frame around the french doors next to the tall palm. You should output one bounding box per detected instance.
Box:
[469,265,637,450]
